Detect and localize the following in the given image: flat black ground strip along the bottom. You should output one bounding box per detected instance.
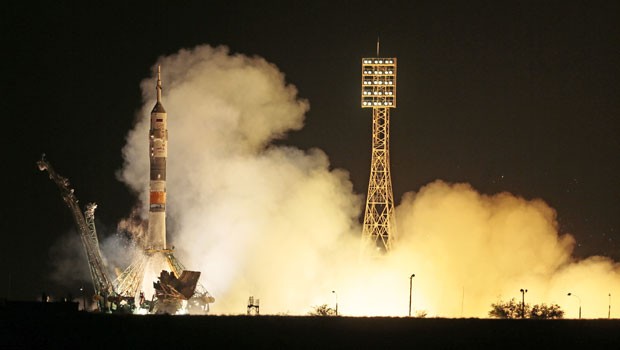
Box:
[0,300,620,350]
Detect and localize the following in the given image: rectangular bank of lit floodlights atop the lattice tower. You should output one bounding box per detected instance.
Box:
[362,57,396,108]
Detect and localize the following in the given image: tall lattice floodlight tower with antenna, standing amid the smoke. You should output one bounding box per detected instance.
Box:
[362,52,396,255]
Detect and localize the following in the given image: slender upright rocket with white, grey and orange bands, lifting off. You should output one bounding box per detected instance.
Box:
[147,66,168,250]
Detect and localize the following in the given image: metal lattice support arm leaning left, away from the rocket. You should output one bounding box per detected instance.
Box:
[37,154,114,297]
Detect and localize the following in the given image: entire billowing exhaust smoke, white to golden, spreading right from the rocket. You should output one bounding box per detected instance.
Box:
[120,46,620,317]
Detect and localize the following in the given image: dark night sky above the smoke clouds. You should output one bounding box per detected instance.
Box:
[0,0,620,299]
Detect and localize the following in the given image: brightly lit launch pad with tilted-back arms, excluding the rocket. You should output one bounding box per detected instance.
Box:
[37,155,215,314]
